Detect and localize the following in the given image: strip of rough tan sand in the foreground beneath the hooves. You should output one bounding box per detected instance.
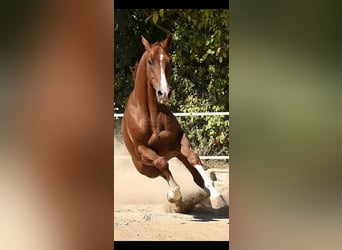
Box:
[114,204,229,241]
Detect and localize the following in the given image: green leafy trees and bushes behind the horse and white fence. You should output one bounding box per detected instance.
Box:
[114,9,229,155]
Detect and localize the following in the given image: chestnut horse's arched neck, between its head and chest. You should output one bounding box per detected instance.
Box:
[134,53,158,127]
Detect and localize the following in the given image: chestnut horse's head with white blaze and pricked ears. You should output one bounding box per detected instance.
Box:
[141,35,172,104]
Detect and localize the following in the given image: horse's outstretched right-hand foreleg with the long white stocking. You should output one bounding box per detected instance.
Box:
[178,133,226,209]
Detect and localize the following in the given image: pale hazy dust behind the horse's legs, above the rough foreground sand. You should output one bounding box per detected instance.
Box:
[114,138,200,206]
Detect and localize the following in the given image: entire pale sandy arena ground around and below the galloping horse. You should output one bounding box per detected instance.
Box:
[114,140,229,241]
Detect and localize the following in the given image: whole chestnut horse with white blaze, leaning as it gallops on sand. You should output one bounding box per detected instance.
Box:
[121,35,226,209]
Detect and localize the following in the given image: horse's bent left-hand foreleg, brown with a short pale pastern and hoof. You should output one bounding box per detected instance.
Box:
[138,145,182,203]
